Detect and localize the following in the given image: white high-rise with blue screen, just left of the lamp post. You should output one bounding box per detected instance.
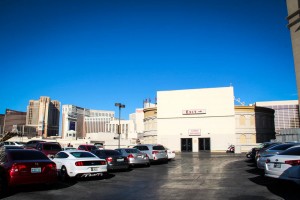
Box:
[62,105,115,138]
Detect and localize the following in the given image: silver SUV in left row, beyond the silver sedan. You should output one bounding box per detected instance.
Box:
[133,144,168,162]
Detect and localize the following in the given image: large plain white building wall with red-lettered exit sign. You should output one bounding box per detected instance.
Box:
[157,87,236,152]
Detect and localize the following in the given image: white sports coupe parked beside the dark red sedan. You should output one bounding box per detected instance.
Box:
[52,150,107,180]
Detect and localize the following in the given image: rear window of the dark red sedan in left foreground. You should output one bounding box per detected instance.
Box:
[10,150,49,160]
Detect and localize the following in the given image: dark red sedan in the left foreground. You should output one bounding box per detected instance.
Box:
[0,147,57,193]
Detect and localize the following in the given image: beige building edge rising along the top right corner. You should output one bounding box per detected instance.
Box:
[286,0,300,104]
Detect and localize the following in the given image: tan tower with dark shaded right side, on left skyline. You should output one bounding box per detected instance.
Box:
[26,96,60,138]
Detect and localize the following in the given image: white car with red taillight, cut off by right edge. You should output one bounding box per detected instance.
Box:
[265,146,300,184]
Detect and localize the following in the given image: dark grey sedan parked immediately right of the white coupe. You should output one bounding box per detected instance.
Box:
[92,149,129,170]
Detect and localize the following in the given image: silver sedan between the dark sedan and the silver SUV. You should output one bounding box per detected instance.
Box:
[116,148,150,167]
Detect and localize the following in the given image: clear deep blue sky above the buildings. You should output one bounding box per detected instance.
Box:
[0,0,298,119]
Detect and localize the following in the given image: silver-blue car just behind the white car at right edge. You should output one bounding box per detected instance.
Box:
[256,143,300,169]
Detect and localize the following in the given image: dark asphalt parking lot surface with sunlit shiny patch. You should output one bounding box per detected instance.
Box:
[4,153,300,200]
